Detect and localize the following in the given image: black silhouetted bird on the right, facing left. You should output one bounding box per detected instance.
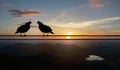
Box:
[37,21,54,36]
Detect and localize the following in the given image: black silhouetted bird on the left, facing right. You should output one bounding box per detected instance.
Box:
[15,21,32,36]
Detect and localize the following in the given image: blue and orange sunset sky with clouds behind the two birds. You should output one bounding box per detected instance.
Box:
[0,0,120,35]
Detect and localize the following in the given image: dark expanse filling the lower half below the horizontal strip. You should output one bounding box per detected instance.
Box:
[0,36,120,70]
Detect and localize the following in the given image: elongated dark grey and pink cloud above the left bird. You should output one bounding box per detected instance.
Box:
[8,9,42,17]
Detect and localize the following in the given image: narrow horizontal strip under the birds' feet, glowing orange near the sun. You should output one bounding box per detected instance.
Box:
[0,35,120,40]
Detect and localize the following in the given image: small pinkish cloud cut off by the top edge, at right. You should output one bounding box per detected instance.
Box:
[89,0,104,8]
